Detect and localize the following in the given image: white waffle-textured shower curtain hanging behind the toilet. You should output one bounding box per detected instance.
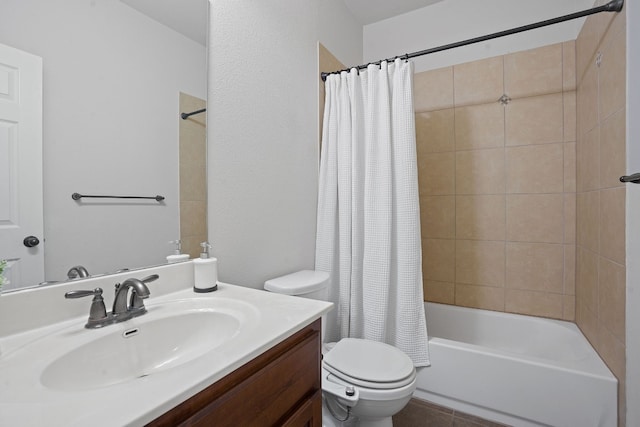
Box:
[316,59,429,366]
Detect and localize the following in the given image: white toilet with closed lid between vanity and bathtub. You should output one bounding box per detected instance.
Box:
[264,270,416,427]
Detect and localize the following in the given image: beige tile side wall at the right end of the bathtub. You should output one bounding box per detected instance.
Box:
[576,2,626,426]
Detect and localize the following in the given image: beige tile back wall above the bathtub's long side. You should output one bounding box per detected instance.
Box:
[414,42,576,320]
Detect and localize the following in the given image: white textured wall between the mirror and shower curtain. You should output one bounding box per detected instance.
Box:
[208,0,362,288]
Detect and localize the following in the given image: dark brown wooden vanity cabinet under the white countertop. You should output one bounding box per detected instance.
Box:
[147,320,322,427]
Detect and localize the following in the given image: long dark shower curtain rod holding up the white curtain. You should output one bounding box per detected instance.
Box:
[320,0,624,81]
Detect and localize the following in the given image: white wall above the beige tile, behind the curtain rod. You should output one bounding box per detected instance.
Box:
[363,0,594,72]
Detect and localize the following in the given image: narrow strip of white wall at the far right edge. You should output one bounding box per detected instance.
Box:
[625,1,640,427]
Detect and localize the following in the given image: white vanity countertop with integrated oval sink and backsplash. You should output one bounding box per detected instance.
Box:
[0,278,331,427]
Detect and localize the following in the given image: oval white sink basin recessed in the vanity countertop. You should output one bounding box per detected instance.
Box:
[41,310,241,391]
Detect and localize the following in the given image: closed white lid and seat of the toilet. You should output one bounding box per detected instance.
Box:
[323,338,415,388]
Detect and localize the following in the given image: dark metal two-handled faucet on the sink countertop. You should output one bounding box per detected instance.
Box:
[64,274,159,329]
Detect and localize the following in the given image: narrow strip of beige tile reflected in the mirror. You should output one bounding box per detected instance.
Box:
[178,93,208,258]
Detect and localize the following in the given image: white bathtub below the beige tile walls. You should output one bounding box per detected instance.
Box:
[414,303,617,427]
